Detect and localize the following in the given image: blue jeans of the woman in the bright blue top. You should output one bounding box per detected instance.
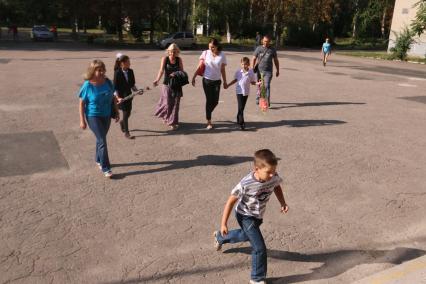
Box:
[87,116,111,173]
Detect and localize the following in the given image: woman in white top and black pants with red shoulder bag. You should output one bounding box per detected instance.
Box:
[192,38,227,129]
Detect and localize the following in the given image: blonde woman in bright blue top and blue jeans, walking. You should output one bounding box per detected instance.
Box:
[78,60,120,178]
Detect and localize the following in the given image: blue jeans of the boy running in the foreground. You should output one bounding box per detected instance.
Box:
[217,213,267,281]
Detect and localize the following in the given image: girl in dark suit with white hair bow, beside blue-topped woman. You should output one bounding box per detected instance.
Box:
[114,53,143,139]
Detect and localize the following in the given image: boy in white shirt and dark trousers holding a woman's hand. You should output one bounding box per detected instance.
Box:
[226,57,257,130]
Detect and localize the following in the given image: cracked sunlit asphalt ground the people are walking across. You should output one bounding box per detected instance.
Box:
[0,43,426,284]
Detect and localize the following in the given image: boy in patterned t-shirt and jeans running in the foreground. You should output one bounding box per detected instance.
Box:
[214,149,289,284]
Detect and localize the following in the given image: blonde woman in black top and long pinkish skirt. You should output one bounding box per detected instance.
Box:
[153,43,184,130]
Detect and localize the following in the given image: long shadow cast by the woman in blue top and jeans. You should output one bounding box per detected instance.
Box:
[111,155,253,179]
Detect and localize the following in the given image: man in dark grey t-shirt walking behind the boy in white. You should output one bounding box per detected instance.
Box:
[252,35,280,106]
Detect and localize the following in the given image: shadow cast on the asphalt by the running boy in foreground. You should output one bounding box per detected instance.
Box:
[224,247,426,284]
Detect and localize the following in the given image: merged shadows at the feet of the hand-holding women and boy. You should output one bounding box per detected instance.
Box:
[131,118,346,137]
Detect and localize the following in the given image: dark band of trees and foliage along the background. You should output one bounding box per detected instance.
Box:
[0,0,400,46]
